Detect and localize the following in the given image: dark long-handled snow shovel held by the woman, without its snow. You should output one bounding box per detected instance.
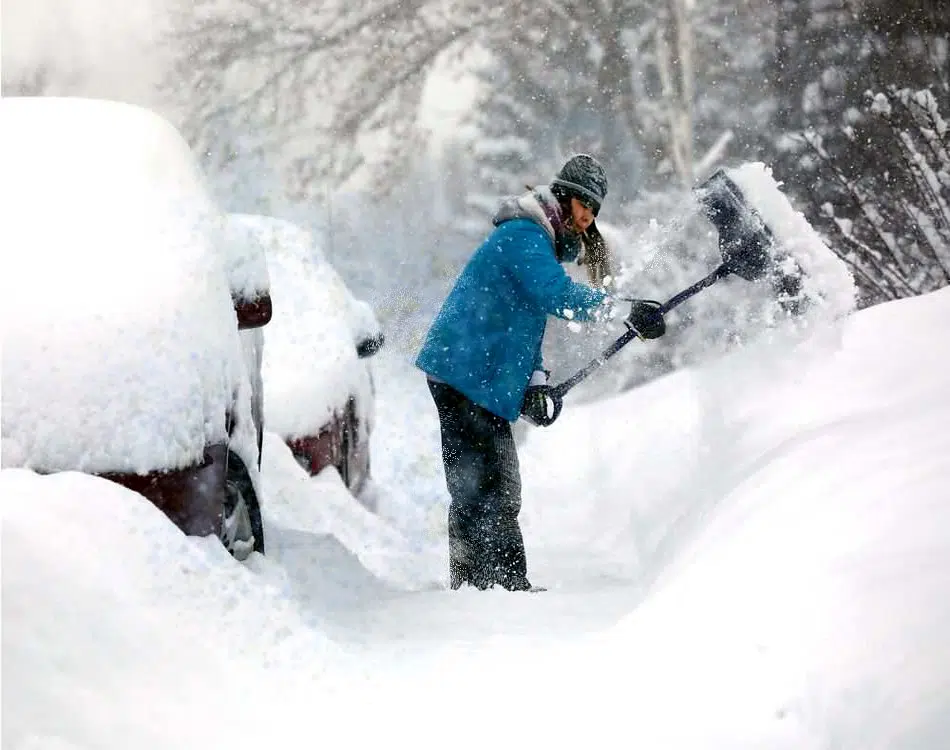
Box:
[552,169,774,397]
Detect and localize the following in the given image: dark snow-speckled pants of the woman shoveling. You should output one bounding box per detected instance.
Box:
[428,380,531,591]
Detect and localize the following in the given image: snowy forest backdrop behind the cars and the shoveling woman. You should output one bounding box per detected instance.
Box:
[3,0,950,393]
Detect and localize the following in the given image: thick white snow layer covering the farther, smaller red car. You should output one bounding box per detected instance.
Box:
[231,214,379,438]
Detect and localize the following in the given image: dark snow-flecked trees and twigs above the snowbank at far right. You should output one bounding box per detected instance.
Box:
[771,0,950,305]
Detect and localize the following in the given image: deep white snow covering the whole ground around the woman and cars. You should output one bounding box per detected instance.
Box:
[0,289,950,750]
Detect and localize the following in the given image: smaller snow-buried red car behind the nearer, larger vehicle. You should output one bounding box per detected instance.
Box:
[230,214,384,496]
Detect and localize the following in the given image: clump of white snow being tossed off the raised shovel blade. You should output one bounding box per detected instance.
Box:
[726,162,857,320]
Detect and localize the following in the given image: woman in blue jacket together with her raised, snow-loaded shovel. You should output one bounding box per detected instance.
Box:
[416,154,850,591]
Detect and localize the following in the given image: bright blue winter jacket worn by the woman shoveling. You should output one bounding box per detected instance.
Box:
[416,218,606,422]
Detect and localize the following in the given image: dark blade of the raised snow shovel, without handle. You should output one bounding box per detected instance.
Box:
[694,169,774,281]
